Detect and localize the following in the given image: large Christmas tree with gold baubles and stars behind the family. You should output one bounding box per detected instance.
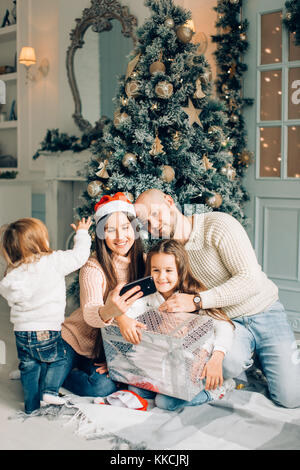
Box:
[73,0,253,252]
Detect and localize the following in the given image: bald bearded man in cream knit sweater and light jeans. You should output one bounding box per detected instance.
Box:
[135,189,300,408]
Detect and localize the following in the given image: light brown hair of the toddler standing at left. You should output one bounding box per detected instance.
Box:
[0,217,52,269]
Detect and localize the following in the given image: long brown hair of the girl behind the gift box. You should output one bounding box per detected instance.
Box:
[145,239,234,327]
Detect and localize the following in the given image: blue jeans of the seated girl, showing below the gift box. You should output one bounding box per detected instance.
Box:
[128,385,212,411]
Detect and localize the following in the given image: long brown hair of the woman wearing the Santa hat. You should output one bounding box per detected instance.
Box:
[93,213,145,362]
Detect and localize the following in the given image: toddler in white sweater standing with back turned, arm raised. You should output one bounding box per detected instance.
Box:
[0,218,91,414]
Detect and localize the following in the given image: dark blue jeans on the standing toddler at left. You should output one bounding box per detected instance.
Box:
[15,331,66,414]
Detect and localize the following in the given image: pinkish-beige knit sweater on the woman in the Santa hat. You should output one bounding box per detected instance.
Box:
[62,256,130,357]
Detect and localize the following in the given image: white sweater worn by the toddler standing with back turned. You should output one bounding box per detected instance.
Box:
[0,230,91,331]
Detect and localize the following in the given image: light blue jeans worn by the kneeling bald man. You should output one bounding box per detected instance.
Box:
[223,301,300,408]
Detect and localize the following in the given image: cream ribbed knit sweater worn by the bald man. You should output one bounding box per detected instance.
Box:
[185,212,278,318]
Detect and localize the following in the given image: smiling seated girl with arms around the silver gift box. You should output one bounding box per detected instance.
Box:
[116,240,235,410]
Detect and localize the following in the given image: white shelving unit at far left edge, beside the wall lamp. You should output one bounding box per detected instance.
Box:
[0,15,20,172]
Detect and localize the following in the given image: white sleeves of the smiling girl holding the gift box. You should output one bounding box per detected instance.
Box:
[126,292,234,354]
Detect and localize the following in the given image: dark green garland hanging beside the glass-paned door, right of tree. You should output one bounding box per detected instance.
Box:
[212,0,254,177]
